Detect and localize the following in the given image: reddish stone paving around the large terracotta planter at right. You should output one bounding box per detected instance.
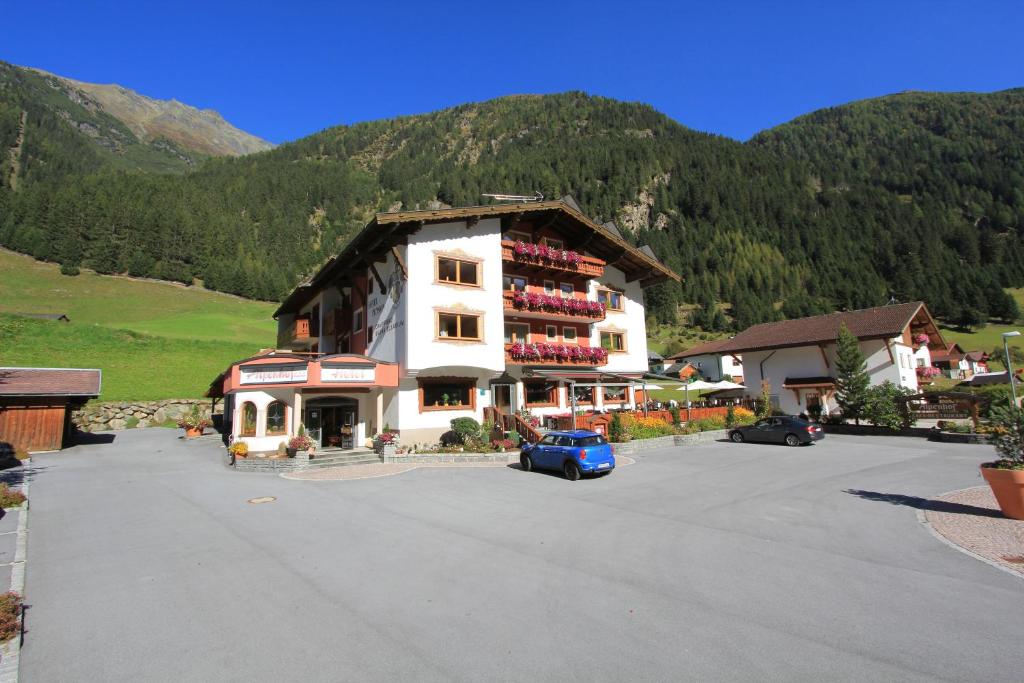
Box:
[925,486,1024,574]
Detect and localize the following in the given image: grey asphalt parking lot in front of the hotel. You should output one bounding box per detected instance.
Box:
[22,429,1024,682]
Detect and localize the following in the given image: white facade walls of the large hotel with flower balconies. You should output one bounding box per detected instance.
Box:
[241,208,671,451]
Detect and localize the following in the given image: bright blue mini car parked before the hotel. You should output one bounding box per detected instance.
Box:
[519,429,615,481]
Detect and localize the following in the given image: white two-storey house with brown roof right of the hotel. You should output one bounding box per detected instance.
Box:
[718,301,947,415]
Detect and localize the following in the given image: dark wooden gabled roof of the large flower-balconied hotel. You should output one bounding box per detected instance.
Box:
[273,200,682,317]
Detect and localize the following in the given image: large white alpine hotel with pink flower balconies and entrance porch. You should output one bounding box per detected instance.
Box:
[211,201,679,451]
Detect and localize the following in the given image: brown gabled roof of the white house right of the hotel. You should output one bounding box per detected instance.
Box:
[718,301,933,353]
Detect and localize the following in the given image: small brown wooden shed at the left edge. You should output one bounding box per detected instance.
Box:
[0,368,102,452]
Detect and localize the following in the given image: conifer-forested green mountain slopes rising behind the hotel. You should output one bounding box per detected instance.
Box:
[0,62,1024,327]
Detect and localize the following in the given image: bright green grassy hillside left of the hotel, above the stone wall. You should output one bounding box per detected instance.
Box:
[0,252,275,400]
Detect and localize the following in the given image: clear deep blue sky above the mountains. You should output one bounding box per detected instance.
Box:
[0,0,1024,142]
